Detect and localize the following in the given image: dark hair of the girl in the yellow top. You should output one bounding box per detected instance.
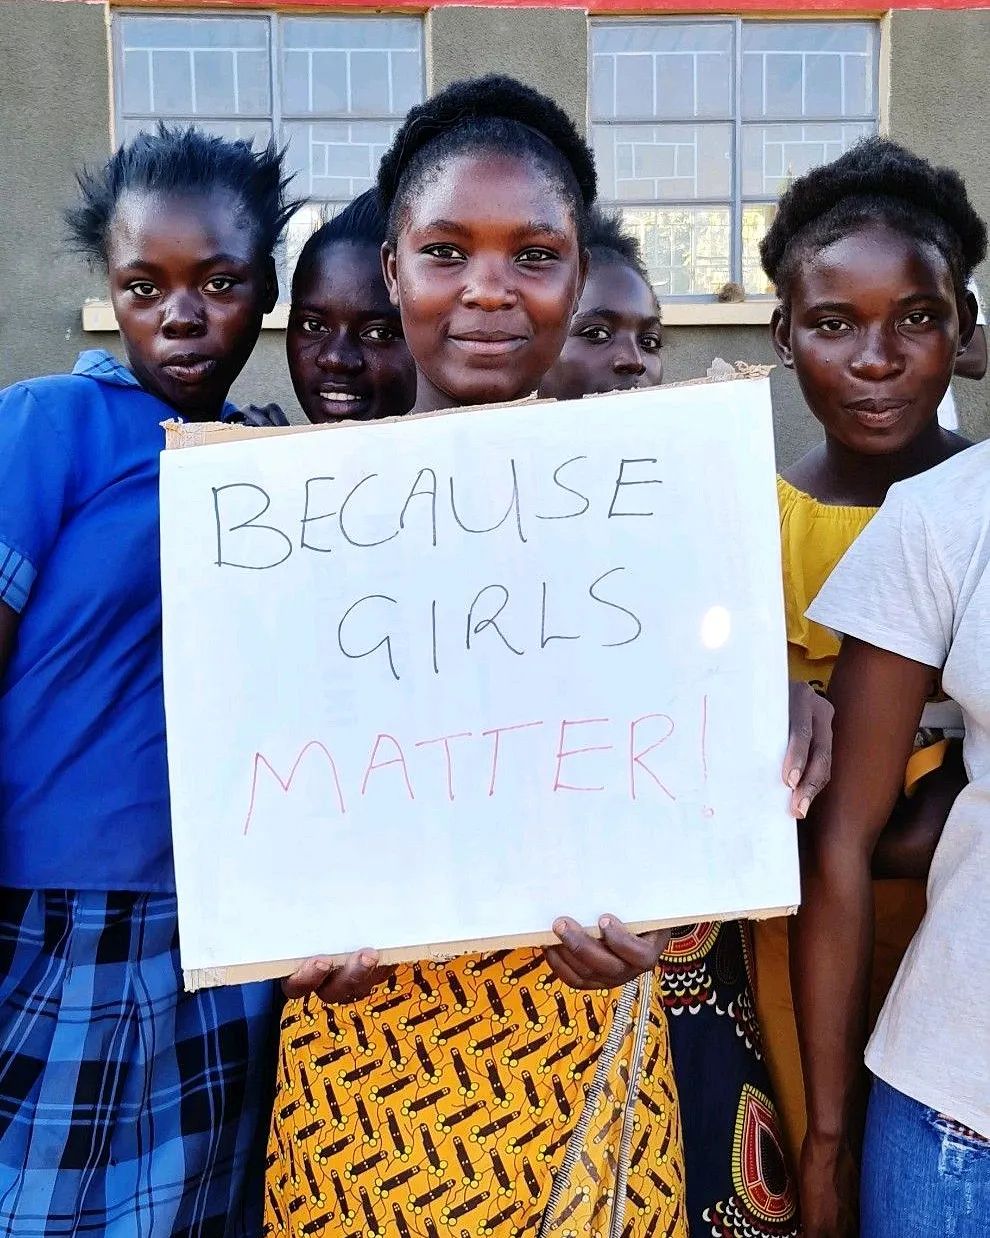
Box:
[760,137,986,308]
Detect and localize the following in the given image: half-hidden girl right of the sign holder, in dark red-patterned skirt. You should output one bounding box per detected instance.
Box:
[541,212,797,1238]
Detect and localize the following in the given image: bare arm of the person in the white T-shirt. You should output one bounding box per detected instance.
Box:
[791,638,932,1238]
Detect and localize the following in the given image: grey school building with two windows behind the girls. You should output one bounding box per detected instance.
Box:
[0,0,990,462]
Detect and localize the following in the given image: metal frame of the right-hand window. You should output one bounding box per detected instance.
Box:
[588,12,882,303]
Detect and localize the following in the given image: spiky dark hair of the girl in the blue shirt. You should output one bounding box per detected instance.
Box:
[66,124,302,265]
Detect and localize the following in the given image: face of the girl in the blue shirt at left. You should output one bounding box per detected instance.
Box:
[106,192,277,421]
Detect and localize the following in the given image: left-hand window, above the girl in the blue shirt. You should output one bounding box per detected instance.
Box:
[114,12,423,267]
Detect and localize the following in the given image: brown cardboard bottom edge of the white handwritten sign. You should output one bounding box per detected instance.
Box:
[182,905,797,993]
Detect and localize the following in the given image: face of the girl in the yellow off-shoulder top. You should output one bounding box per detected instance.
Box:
[772,224,973,456]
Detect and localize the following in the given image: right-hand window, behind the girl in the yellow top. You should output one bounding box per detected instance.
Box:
[592,19,879,297]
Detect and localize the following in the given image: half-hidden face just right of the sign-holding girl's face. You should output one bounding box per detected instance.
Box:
[540,253,663,400]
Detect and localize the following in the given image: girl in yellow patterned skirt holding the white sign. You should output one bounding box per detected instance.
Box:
[267,78,831,1238]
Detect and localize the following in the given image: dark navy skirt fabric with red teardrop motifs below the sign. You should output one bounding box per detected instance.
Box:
[661,921,801,1238]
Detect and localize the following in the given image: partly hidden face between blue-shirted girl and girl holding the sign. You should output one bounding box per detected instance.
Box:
[286,241,416,422]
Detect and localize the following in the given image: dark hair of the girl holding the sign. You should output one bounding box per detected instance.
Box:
[379,74,598,245]
